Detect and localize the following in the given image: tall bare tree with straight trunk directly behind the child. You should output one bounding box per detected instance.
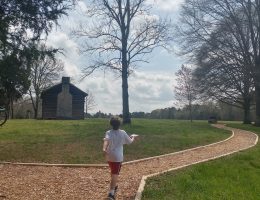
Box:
[73,0,171,123]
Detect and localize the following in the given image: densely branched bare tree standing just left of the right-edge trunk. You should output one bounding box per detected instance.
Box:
[194,23,255,124]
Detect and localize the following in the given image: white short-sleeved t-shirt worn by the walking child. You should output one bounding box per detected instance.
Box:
[104,129,133,162]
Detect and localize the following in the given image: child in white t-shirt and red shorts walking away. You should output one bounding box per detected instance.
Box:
[103,117,137,200]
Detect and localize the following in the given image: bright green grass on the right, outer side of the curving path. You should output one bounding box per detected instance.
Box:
[142,123,260,200]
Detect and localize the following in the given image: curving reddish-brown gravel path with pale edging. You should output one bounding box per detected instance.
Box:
[0,125,257,200]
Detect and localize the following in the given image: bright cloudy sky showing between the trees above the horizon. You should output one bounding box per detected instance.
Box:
[47,0,185,114]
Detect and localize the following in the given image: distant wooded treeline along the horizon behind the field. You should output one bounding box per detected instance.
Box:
[14,99,254,121]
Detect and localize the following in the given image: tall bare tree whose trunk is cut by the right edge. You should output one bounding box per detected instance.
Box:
[178,0,260,125]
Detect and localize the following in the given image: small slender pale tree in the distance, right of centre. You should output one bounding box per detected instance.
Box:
[174,65,197,122]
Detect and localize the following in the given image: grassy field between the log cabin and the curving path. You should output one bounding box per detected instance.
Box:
[0,119,230,163]
